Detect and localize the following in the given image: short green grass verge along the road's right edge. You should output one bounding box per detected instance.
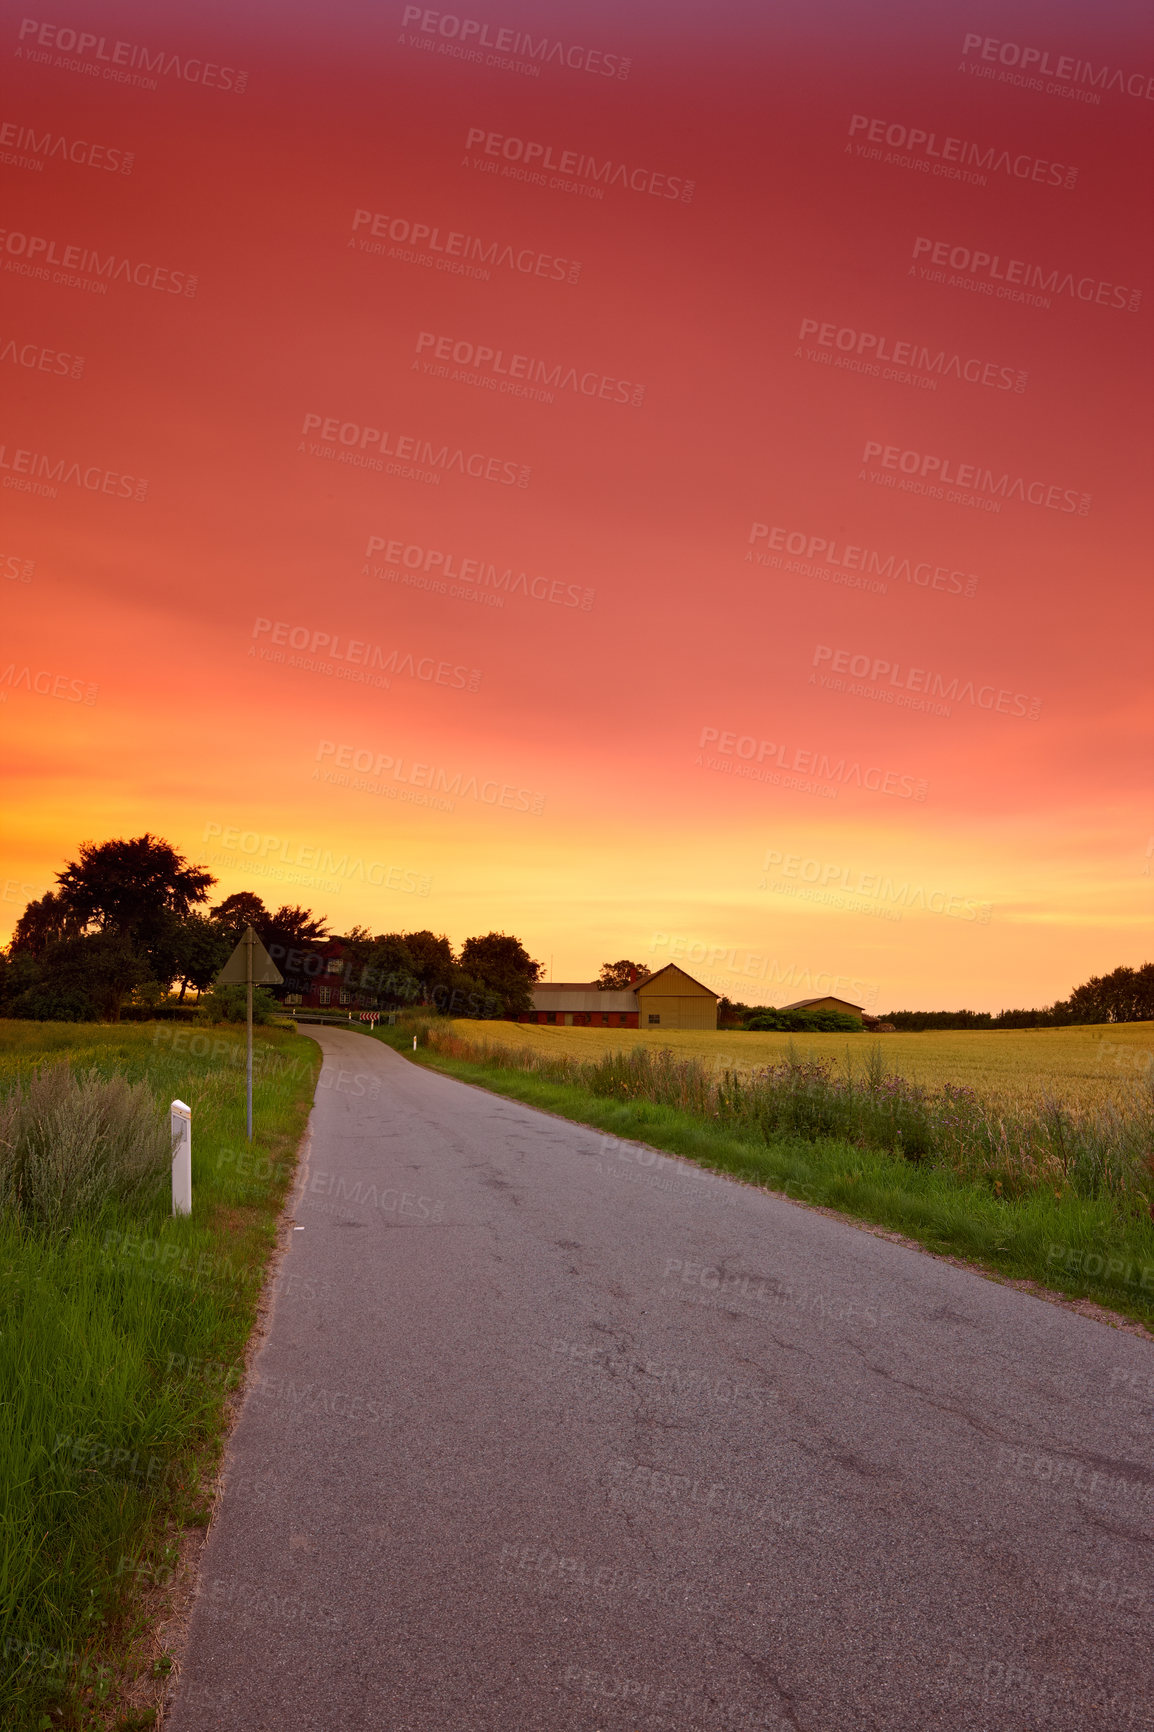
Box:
[376,1018,1154,1327]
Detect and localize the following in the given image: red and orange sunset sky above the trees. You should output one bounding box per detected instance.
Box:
[0,0,1154,1011]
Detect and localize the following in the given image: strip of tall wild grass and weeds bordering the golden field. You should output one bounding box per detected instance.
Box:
[418,1020,1154,1216]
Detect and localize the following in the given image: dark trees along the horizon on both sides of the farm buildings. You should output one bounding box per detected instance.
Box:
[0,831,1154,1032]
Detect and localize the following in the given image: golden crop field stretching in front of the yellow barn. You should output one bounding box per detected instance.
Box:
[441,1020,1154,1107]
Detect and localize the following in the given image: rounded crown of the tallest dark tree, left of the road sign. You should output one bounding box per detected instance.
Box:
[55,831,217,953]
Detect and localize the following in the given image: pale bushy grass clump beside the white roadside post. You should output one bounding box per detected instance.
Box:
[0,1063,172,1231]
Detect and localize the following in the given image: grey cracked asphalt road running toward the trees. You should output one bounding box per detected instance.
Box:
[170,1029,1154,1732]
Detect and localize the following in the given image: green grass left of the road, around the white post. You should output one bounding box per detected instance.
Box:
[0,1022,319,1732]
